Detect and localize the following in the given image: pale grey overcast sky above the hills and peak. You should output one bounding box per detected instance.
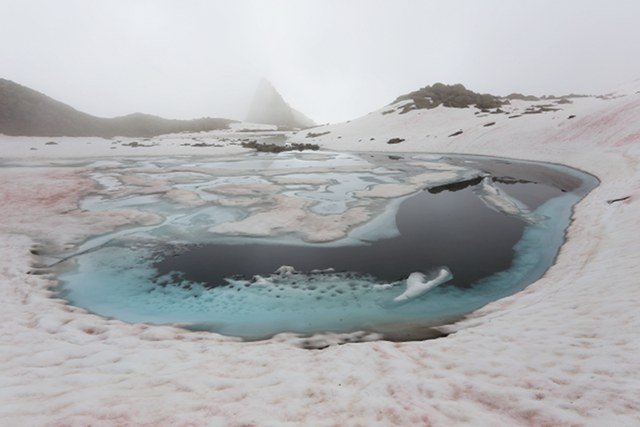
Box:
[0,0,640,123]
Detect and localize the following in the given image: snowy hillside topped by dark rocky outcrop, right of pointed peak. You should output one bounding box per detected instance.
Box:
[290,83,624,151]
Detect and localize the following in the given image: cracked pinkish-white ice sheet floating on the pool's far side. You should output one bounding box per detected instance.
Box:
[70,153,482,244]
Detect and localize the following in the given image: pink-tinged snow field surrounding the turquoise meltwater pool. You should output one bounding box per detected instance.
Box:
[0,87,640,426]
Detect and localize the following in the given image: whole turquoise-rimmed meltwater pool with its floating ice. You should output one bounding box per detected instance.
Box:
[54,152,597,340]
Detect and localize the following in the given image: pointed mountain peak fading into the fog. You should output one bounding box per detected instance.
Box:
[247,79,316,128]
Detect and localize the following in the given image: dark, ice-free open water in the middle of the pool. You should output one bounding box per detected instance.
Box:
[154,183,561,287]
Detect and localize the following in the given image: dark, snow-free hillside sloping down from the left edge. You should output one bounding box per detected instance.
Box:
[0,79,232,137]
